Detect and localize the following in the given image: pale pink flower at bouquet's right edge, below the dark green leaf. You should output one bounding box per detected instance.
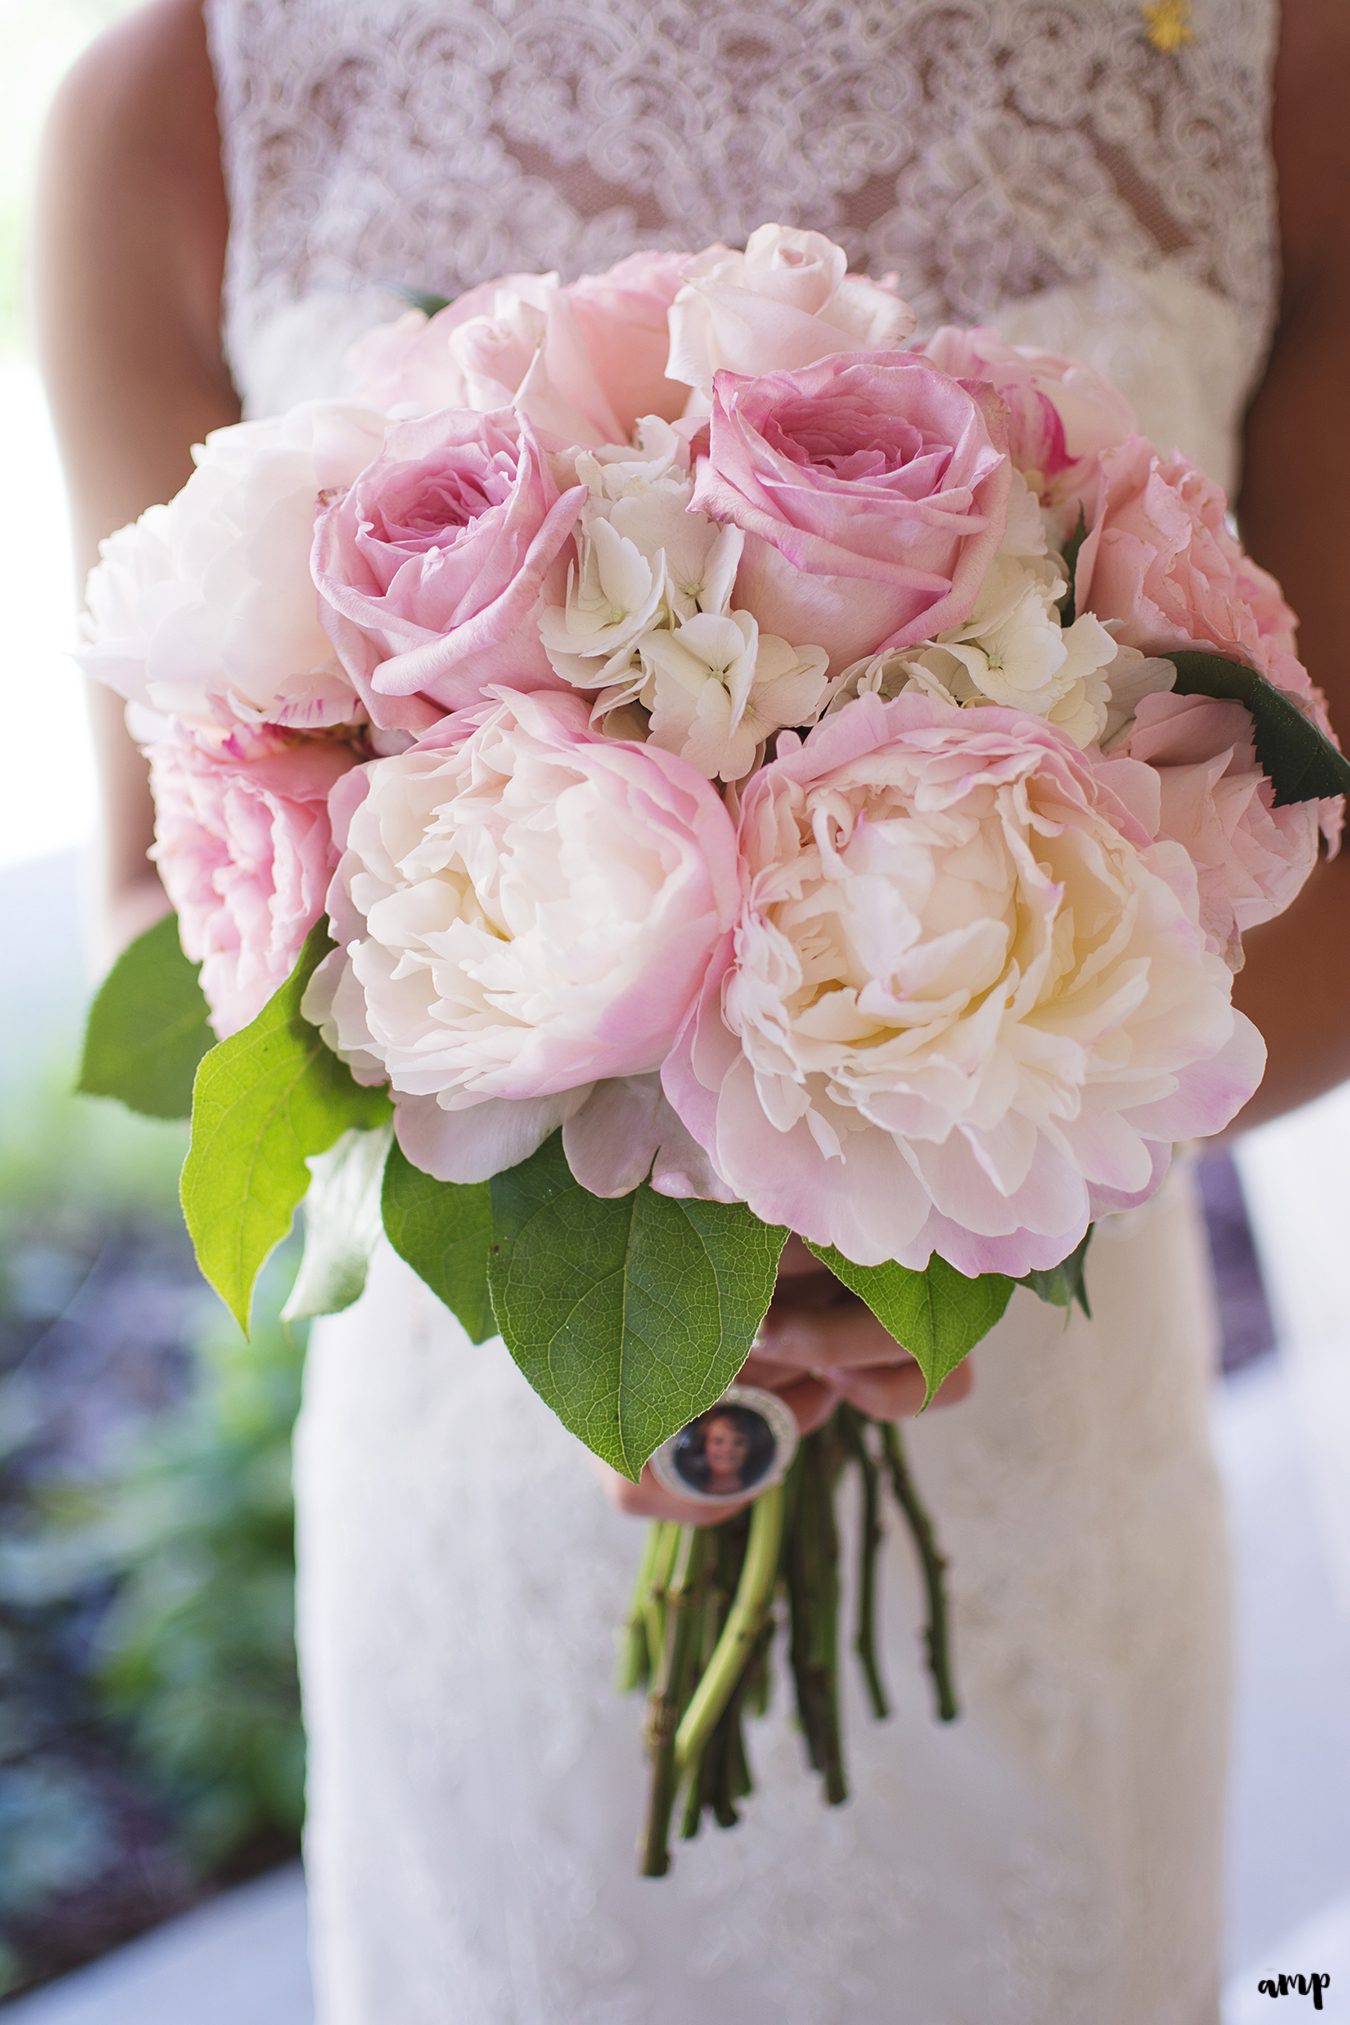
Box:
[1125,695,1322,970]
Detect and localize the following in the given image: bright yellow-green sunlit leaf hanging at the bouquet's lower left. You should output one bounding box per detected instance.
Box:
[180,925,389,1334]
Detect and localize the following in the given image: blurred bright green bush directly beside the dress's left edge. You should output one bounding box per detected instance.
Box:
[87,1287,304,1865]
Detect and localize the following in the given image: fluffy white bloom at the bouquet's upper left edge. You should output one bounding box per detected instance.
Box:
[79,401,385,735]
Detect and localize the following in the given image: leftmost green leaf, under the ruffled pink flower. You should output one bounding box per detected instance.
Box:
[75,913,215,1118]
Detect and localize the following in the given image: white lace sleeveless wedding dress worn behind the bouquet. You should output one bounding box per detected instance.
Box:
[208,0,1275,2025]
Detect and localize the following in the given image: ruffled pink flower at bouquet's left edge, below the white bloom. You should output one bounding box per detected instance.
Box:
[148,729,358,1037]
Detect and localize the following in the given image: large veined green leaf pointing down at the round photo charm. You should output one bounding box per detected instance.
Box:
[488,1136,787,1480]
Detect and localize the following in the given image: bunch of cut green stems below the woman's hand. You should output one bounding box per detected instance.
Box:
[619,1405,957,1877]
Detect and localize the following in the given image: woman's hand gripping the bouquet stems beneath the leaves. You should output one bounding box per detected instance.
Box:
[595,1237,974,1525]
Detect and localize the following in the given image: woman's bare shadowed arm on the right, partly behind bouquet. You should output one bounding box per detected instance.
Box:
[1237,0,1350,1124]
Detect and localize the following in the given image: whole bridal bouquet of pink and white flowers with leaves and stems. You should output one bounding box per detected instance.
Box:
[83,225,1350,1871]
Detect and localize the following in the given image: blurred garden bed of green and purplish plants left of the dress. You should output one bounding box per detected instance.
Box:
[0,1077,302,1995]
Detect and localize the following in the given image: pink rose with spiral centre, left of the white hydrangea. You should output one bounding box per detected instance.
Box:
[314,409,587,731]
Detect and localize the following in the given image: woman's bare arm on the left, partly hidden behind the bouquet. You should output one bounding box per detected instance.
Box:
[36,0,239,948]
